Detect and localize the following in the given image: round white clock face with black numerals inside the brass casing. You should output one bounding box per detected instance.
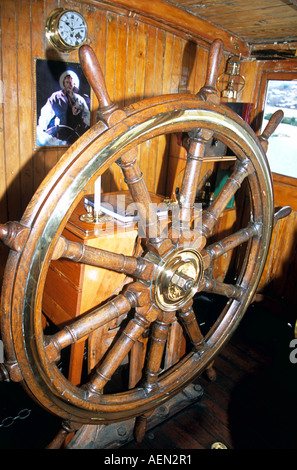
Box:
[58,11,87,47]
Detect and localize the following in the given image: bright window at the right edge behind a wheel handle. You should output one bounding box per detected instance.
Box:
[262,79,297,178]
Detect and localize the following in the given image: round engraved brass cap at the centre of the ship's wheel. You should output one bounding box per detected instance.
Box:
[154,249,203,311]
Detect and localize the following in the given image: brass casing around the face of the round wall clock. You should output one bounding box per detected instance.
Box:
[45,8,88,52]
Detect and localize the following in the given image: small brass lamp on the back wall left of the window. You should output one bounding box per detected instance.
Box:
[218,56,245,101]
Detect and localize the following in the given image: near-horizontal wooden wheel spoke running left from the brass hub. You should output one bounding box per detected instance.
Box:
[52,236,155,280]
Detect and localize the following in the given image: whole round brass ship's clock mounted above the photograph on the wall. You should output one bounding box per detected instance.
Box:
[45,8,88,52]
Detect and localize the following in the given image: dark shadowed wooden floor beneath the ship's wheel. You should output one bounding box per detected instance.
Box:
[0,300,297,451]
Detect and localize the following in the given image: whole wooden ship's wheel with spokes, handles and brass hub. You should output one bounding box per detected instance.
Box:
[0,40,288,446]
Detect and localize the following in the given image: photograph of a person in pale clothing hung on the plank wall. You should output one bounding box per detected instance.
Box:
[36,59,91,147]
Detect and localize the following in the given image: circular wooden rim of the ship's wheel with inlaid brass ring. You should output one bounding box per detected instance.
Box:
[2,95,273,424]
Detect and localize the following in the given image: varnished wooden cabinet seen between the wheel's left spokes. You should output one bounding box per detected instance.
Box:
[42,196,137,384]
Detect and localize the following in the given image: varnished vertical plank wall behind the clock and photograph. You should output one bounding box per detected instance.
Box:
[0,0,217,228]
